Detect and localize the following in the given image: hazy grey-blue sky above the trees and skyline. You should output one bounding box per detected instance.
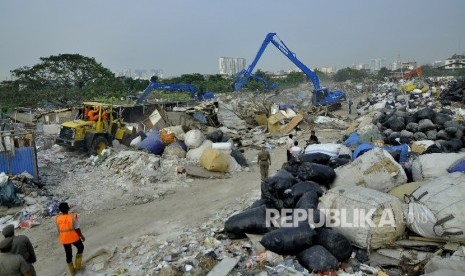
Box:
[0,0,465,81]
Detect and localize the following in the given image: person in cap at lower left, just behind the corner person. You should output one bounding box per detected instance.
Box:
[2,224,37,276]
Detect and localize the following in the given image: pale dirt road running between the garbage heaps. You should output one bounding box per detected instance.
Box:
[17,92,356,275]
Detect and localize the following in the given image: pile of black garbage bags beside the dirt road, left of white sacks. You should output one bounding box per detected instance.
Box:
[225,153,352,272]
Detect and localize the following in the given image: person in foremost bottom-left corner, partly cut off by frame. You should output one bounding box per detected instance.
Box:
[0,237,32,276]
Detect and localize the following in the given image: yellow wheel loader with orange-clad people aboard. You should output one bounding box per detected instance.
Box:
[56,102,133,155]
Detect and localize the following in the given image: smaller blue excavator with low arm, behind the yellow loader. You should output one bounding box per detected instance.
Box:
[135,77,214,105]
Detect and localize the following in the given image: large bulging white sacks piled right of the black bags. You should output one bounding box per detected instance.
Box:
[300,144,465,254]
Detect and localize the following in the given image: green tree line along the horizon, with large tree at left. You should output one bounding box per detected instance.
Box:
[0,54,465,109]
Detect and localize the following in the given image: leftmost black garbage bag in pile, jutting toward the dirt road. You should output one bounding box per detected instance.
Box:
[224,205,273,238]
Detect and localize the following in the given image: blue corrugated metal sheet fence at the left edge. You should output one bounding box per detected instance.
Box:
[0,147,38,179]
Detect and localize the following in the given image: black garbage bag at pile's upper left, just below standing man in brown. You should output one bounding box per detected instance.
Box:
[261,169,297,209]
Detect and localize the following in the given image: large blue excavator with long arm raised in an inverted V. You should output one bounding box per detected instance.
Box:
[234,33,345,106]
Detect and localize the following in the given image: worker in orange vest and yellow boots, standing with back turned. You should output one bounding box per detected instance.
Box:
[55,202,86,275]
